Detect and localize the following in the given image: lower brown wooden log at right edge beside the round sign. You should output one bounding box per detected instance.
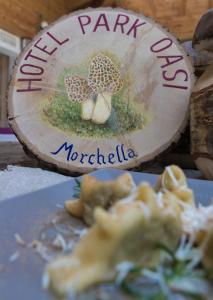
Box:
[191,64,213,180]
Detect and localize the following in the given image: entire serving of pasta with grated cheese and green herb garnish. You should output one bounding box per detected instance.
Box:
[45,166,213,300]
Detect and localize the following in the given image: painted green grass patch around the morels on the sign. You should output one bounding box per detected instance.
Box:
[43,66,146,138]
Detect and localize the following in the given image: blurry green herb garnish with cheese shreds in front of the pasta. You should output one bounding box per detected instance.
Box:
[116,241,211,300]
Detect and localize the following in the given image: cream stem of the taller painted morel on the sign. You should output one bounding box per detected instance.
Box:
[92,92,112,124]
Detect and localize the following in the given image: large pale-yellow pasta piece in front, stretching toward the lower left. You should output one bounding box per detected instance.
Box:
[47,186,181,295]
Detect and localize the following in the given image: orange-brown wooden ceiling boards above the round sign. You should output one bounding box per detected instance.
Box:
[0,0,213,40]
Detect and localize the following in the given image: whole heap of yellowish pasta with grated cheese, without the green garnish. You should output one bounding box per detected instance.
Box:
[45,165,213,296]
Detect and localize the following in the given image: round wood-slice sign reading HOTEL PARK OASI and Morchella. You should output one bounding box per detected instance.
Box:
[8,8,194,172]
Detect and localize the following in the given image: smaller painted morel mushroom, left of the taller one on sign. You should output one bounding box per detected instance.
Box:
[64,76,95,120]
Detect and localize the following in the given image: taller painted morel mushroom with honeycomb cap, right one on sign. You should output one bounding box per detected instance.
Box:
[88,53,123,124]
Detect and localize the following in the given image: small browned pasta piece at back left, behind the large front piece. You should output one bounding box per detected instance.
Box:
[65,173,135,225]
